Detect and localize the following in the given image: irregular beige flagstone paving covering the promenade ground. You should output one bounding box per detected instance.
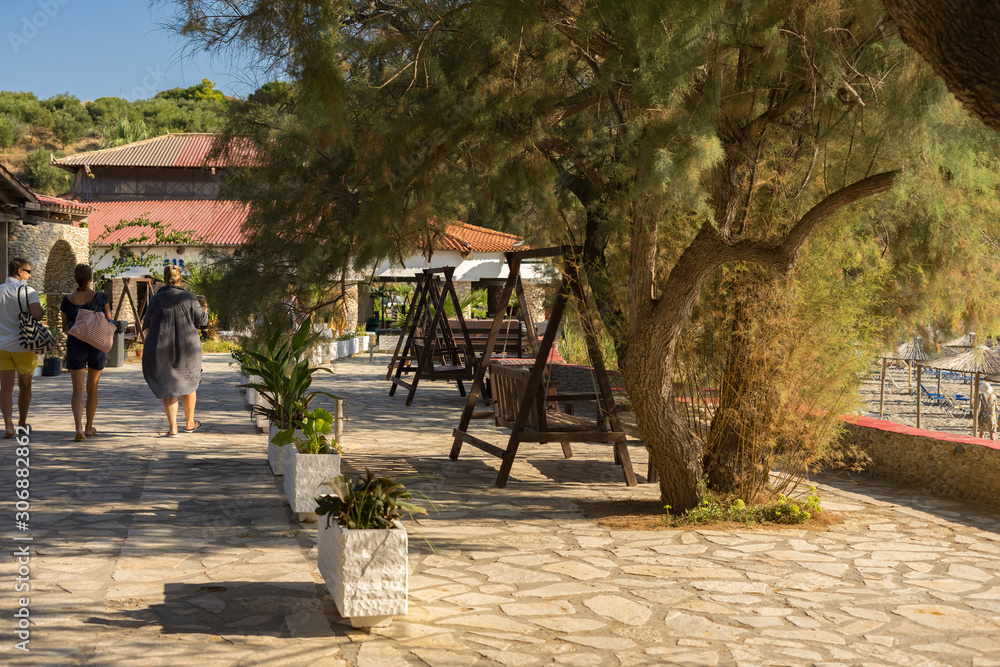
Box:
[0,356,1000,667]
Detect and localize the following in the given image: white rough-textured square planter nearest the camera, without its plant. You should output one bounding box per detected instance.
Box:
[318,517,410,628]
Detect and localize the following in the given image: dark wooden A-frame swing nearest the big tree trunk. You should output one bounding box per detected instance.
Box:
[450,246,636,488]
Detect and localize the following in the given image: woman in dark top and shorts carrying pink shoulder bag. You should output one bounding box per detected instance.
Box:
[59,264,111,442]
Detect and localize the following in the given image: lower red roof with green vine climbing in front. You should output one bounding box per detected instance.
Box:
[87,204,247,245]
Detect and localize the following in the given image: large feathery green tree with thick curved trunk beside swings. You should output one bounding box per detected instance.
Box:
[170,0,1000,509]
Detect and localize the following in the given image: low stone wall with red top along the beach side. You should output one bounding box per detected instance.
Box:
[844,417,1000,508]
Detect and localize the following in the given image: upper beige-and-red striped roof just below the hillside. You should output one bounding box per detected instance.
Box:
[52,133,253,171]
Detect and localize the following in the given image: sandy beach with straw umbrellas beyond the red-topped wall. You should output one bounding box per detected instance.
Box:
[861,366,1000,439]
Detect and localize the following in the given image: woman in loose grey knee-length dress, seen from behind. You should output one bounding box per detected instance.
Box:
[142,266,208,437]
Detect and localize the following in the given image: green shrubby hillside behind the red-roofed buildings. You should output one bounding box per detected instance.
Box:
[0,79,229,195]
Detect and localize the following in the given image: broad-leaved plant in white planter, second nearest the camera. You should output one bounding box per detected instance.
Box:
[271,408,341,518]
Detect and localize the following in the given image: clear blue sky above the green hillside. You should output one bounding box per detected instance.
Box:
[0,0,264,100]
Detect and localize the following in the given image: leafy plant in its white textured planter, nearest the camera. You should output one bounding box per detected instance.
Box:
[316,470,427,627]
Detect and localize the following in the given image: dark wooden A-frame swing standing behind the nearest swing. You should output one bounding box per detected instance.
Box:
[386,266,475,406]
